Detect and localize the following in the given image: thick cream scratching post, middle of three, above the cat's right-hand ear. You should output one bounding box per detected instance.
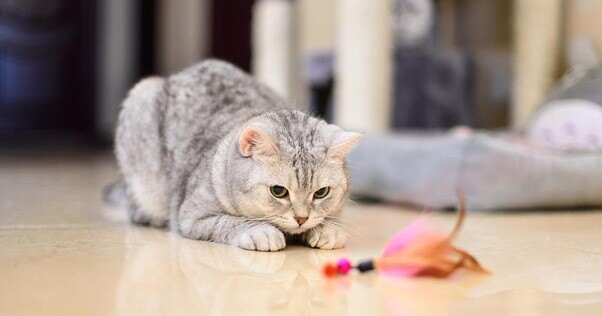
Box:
[334,0,392,132]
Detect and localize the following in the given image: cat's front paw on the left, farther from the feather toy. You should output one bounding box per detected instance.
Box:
[236,224,286,251]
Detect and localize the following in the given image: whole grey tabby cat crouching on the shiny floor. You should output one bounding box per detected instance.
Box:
[115,60,362,251]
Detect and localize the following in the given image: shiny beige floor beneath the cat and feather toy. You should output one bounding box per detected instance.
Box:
[0,154,602,315]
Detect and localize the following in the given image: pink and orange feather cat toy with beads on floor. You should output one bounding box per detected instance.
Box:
[322,193,487,278]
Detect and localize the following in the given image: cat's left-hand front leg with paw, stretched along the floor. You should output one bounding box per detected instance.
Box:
[178,200,286,251]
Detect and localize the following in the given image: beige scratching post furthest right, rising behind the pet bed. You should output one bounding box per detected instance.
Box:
[512,0,562,129]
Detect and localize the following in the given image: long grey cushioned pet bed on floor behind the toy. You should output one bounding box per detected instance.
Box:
[348,133,602,209]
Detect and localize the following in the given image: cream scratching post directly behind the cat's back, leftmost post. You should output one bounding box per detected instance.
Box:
[253,0,298,100]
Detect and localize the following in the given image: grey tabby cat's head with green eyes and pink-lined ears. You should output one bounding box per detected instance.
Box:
[220,110,362,234]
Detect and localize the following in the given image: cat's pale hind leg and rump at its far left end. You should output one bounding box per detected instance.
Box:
[115,77,169,227]
